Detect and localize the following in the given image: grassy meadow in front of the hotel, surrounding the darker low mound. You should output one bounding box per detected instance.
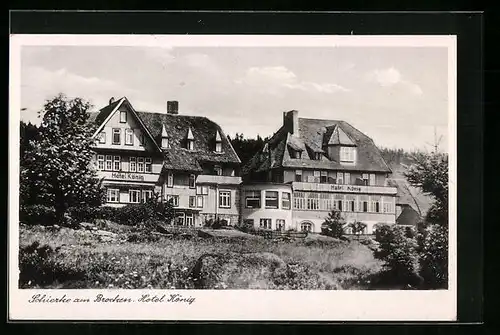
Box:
[20,226,381,289]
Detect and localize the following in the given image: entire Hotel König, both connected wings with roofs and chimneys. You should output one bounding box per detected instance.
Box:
[91,97,398,234]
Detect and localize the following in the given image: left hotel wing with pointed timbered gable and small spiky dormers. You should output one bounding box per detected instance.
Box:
[91,97,241,226]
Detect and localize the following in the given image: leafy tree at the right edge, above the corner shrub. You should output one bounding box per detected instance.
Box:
[404,151,448,226]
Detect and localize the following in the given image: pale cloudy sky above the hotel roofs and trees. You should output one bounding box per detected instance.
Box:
[21,46,448,151]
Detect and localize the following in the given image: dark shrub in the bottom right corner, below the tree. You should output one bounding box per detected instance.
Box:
[419,225,448,289]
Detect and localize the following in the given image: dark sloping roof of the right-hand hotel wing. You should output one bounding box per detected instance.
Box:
[242,118,391,174]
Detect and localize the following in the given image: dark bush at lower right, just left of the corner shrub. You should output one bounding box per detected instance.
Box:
[374,225,421,287]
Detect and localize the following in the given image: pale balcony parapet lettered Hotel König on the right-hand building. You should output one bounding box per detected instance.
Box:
[292,182,398,195]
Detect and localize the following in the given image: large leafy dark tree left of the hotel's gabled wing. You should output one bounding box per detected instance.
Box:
[21,94,104,224]
